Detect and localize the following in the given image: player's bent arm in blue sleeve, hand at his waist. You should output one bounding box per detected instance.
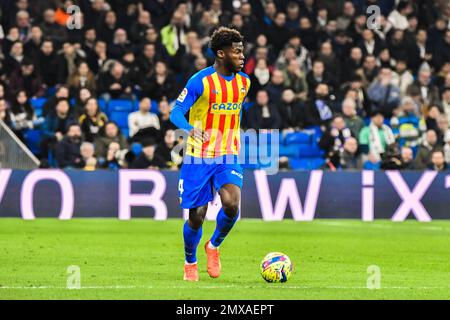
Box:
[170,77,209,141]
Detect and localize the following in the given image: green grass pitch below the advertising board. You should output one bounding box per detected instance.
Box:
[0,218,450,300]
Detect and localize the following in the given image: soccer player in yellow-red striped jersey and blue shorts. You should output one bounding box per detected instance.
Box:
[170,27,250,281]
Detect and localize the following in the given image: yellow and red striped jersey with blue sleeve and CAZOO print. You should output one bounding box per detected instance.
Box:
[176,66,250,158]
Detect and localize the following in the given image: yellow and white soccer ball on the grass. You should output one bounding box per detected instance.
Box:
[261,252,293,282]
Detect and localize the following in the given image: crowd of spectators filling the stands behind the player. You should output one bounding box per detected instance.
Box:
[0,0,450,170]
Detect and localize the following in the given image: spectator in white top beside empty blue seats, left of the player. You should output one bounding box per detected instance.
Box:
[128,98,161,141]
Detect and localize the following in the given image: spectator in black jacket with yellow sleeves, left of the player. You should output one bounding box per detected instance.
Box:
[78,98,108,142]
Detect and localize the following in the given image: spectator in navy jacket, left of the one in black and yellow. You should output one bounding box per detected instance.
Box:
[41,98,78,159]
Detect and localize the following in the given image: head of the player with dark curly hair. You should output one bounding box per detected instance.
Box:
[210,27,244,73]
